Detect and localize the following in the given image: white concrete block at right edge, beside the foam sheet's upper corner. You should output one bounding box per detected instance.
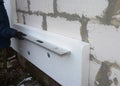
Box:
[88,24,120,63]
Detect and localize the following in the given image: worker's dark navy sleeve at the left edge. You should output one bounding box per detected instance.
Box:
[0,4,17,38]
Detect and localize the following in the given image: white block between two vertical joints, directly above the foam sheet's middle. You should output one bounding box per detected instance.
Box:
[47,17,81,40]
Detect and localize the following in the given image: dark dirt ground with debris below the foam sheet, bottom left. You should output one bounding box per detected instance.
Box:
[4,56,41,86]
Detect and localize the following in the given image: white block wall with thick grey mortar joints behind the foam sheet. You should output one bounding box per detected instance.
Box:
[9,0,120,86]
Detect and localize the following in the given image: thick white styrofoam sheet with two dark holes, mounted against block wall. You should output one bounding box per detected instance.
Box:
[12,24,89,86]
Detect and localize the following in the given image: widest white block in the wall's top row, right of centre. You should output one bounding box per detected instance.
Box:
[57,0,108,17]
